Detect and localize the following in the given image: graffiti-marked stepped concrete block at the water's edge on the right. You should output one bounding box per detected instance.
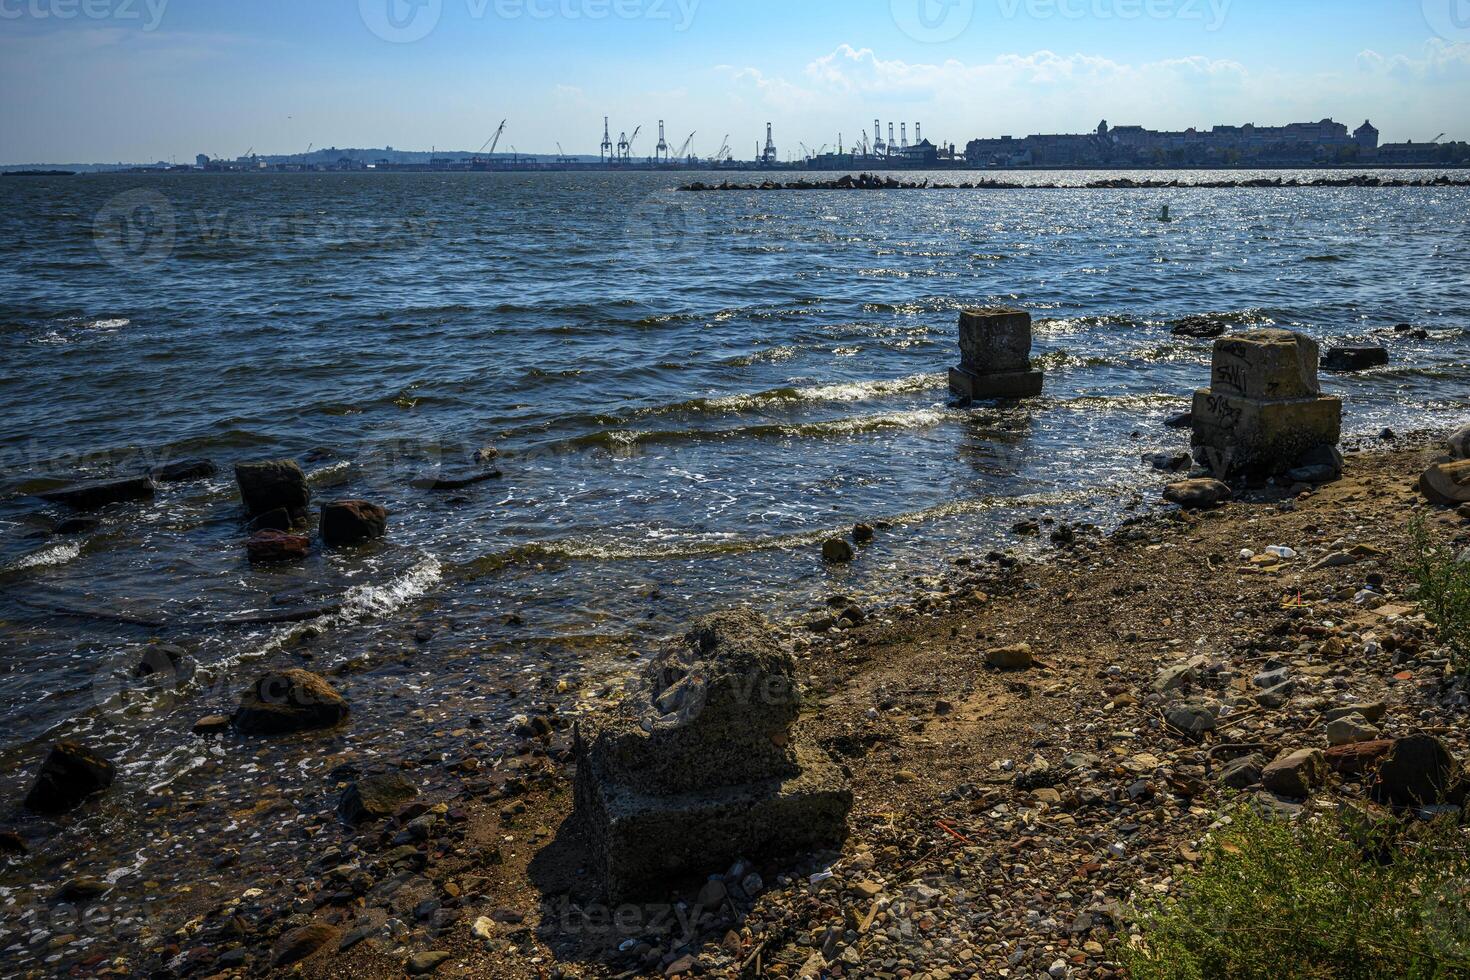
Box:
[1194,329,1342,479]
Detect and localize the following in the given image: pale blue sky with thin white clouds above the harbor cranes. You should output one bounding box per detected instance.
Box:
[0,0,1470,165]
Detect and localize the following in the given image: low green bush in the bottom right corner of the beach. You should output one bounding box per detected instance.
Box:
[1117,807,1470,980]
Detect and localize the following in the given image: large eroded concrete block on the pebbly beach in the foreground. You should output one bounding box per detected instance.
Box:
[576,611,853,901]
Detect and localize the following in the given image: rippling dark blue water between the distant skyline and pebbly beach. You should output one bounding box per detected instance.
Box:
[0,173,1470,934]
